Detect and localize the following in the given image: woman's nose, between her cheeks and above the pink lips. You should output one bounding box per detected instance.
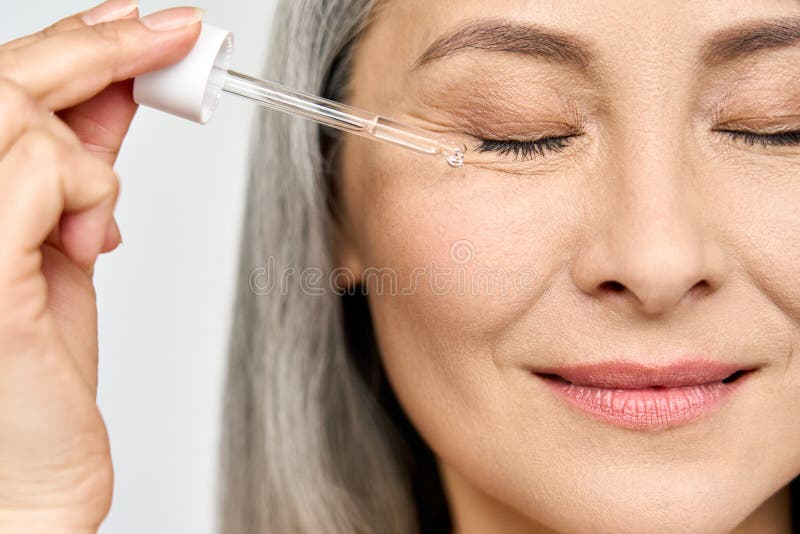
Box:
[571,147,725,315]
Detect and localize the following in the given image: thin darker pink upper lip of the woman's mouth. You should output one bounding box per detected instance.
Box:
[534,359,753,389]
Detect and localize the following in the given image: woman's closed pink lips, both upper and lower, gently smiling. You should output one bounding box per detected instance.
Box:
[533,359,753,429]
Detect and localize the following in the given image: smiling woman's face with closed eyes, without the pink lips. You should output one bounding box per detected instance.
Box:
[338,0,800,532]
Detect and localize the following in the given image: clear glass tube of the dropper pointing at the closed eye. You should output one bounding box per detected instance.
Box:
[212,68,466,167]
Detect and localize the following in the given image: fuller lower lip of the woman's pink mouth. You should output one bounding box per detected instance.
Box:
[534,373,751,430]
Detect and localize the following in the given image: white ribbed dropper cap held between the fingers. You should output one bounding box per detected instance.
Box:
[133,23,233,124]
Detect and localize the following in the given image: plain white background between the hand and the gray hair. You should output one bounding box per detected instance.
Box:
[0,0,275,534]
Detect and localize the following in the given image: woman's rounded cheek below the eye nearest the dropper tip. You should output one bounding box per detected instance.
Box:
[346,143,575,341]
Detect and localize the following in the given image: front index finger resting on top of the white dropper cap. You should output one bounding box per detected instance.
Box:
[0,7,204,110]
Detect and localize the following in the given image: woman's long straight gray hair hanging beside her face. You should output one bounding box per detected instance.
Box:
[219,0,450,534]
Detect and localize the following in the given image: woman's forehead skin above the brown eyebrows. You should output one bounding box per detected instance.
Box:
[360,0,800,77]
